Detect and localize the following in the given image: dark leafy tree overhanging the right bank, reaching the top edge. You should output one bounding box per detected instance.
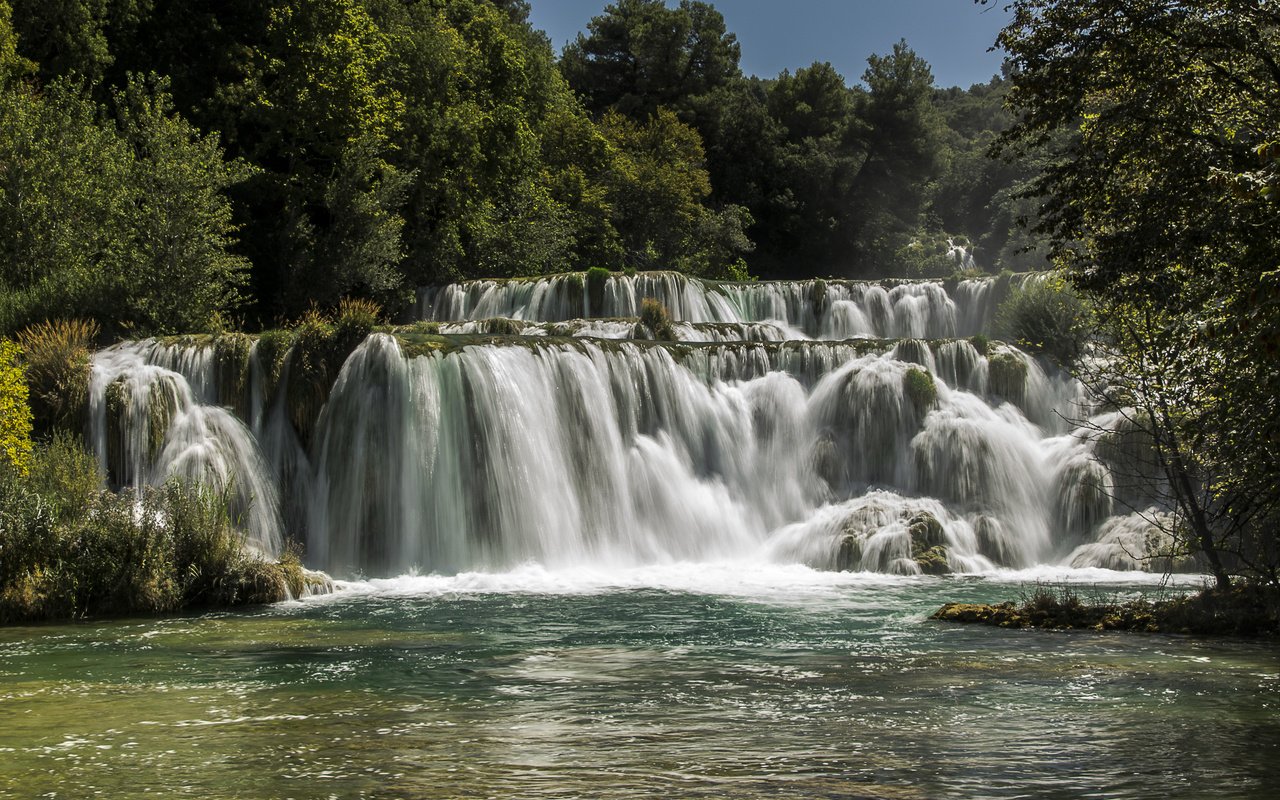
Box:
[998,0,1280,584]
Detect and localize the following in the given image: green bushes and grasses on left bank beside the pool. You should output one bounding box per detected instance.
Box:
[0,434,303,622]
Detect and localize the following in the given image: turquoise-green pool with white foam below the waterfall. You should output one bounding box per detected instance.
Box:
[0,566,1280,799]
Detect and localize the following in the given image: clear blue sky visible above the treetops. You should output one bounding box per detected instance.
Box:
[529,0,1009,88]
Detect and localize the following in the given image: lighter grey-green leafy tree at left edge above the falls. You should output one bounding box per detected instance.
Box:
[0,74,246,333]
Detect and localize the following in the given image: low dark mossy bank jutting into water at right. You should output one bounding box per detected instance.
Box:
[929,584,1280,637]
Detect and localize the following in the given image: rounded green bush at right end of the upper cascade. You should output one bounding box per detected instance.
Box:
[996,275,1092,367]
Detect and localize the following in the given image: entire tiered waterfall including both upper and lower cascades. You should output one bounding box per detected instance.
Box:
[92,273,1172,576]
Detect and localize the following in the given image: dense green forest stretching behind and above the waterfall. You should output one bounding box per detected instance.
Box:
[0,0,1027,334]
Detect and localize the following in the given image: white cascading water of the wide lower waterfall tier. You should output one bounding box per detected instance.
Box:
[85,321,1167,577]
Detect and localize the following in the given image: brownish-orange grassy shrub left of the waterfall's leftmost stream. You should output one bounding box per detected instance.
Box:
[18,320,99,430]
